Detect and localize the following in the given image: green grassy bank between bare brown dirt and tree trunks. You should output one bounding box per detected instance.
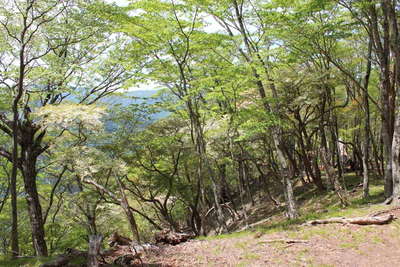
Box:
[198,173,384,240]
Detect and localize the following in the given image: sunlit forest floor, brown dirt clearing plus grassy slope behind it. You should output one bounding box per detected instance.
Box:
[143,175,400,267]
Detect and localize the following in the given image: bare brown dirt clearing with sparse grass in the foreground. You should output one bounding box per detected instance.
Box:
[145,210,400,267]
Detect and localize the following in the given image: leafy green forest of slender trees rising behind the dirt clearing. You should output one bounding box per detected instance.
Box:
[0,0,400,266]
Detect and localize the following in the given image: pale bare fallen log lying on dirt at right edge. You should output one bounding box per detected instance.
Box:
[305,214,395,225]
